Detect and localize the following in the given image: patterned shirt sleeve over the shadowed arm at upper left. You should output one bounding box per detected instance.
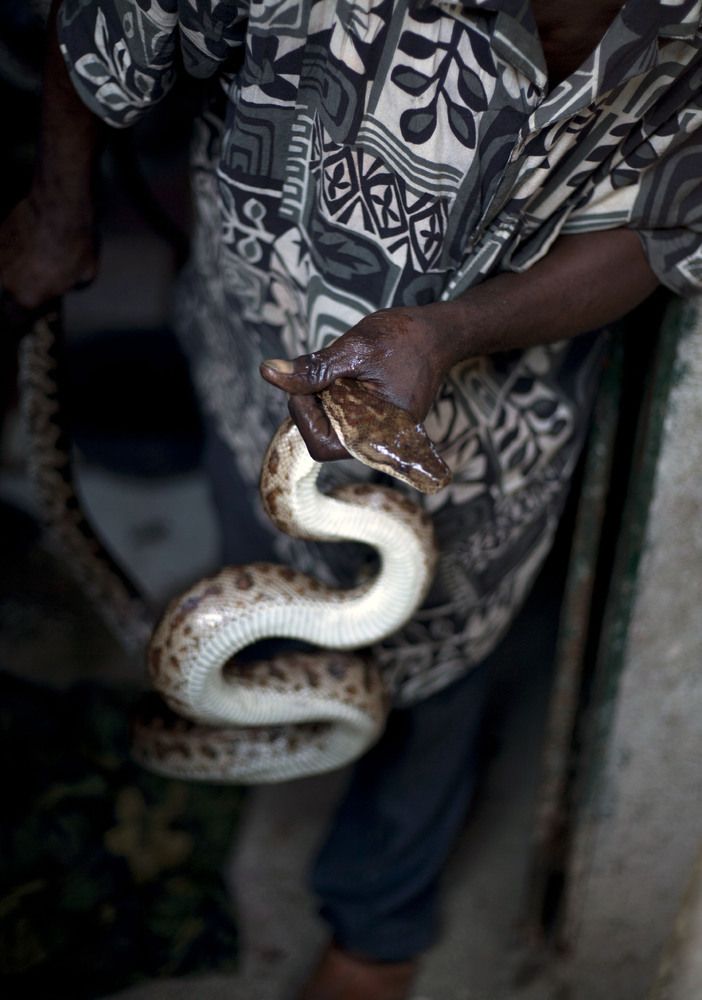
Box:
[58,0,248,127]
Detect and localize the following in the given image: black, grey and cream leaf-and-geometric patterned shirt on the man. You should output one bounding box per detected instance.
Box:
[60,0,702,700]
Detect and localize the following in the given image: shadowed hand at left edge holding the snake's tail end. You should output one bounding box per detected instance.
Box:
[0,195,97,314]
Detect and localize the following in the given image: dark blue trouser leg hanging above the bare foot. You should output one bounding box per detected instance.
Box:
[312,663,489,962]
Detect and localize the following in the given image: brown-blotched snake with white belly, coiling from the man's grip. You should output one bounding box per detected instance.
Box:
[20,313,451,784]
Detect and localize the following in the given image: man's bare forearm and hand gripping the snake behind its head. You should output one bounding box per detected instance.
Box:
[261,229,658,461]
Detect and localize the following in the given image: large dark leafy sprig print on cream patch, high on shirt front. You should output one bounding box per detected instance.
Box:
[391,25,487,149]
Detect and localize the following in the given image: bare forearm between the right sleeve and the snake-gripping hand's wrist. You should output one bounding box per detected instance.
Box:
[426,229,658,368]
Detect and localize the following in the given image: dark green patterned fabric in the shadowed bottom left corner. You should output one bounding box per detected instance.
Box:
[0,674,241,1000]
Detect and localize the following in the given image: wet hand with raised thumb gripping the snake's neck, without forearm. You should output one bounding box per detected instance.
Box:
[261,305,450,462]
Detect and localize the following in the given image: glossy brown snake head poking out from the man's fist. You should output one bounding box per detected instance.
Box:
[319,379,451,493]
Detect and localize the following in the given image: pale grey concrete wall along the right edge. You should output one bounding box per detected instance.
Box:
[565,301,702,1000]
